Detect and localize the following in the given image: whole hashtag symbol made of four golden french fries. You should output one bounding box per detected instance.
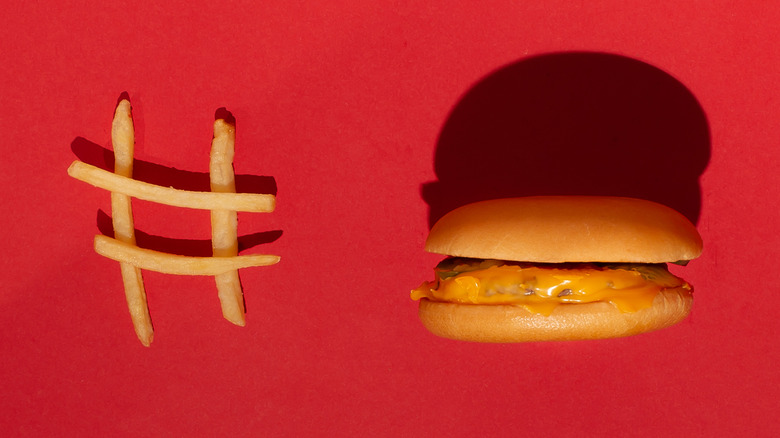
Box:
[68,99,279,347]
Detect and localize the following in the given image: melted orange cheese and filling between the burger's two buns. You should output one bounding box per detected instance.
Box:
[411,259,690,315]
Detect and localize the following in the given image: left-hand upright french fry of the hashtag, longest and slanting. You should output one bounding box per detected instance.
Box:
[111,100,154,347]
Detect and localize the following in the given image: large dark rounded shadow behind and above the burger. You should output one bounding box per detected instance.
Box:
[421,52,710,226]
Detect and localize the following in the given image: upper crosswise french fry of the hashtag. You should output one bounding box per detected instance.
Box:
[68,160,276,213]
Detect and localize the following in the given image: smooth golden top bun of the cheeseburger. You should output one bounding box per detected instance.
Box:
[425,196,702,263]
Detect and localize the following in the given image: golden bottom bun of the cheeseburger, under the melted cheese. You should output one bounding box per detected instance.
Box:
[419,288,693,342]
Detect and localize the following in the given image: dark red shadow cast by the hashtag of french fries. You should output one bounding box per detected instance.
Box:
[71,105,282,257]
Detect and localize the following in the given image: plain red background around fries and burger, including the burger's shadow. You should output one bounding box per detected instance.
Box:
[0,0,780,436]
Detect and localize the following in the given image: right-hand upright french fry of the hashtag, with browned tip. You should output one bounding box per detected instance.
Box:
[209,119,246,327]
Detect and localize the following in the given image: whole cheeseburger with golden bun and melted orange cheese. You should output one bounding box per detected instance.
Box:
[412,196,702,342]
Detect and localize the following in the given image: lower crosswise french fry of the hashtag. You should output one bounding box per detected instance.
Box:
[95,234,280,276]
